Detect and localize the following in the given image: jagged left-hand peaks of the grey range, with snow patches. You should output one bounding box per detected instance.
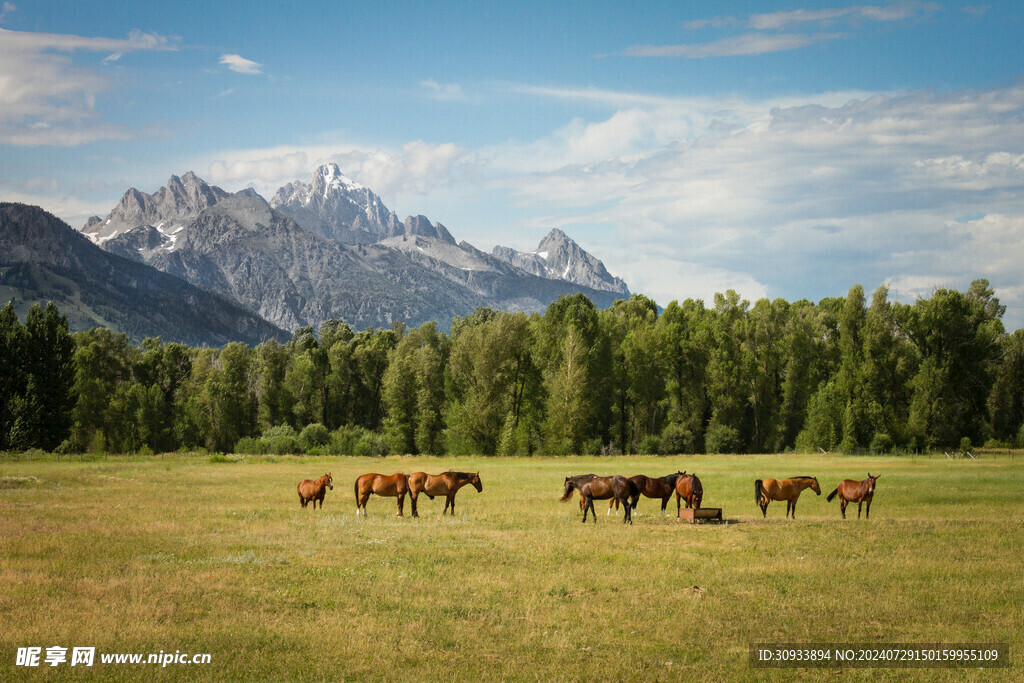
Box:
[82,171,229,244]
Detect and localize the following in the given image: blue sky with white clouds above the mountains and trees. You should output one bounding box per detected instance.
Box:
[0,0,1024,330]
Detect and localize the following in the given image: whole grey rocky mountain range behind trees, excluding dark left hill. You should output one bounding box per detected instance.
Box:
[83,164,628,330]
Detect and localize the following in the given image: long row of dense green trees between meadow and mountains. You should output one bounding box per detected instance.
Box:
[0,280,1024,455]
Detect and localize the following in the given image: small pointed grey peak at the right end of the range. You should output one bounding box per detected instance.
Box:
[492,228,630,298]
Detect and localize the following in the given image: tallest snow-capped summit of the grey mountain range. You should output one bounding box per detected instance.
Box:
[270,164,403,244]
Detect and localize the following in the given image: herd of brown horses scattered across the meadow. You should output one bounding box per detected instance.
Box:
[298,472,881,524]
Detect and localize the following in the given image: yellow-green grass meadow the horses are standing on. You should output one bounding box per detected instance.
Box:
[0,456,1024,681]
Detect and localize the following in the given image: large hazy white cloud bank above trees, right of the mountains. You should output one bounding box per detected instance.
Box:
[486,86,1024,329]
